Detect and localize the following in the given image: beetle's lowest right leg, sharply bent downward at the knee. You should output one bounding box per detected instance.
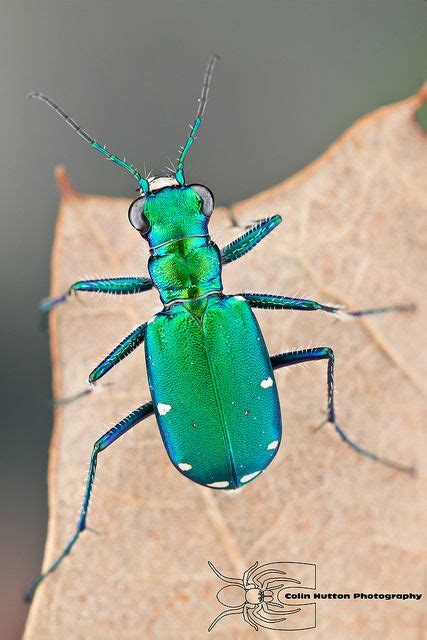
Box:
[271,347,414,473]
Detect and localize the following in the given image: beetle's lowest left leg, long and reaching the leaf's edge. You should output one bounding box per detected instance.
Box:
[25,402,153,601]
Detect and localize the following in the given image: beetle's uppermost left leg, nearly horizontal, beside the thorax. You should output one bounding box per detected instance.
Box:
[40,276,153,313]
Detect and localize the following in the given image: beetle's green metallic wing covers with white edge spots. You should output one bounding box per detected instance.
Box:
[145,294,281,489]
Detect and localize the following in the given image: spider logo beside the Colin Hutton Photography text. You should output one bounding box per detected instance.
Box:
[208,562,315,631]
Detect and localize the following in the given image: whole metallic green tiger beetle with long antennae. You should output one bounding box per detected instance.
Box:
[27,55,413,599]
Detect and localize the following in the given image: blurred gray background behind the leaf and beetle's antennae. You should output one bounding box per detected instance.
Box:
[0,0,427,640]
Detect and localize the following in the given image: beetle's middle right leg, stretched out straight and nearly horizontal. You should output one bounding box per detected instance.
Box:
[242,293,415,318]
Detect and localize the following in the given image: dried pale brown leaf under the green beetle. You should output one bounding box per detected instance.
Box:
[25,85,427,640]
